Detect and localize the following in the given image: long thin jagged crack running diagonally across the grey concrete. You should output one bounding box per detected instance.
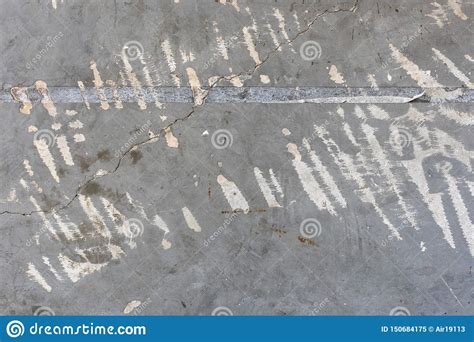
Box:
[0,0,359,216]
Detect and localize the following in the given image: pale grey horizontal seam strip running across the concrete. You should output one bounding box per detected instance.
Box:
[0,86,474,104]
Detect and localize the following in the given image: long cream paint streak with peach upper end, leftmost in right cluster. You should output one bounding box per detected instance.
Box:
[287,143,336,215]
